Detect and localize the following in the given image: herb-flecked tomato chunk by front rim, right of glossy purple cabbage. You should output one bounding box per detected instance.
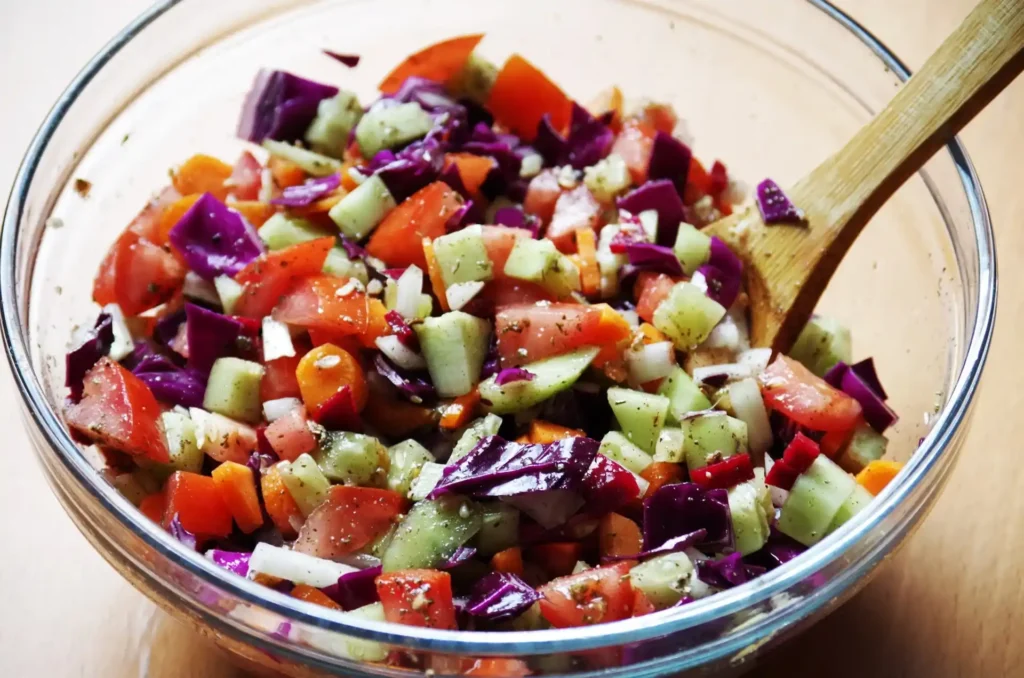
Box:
[540,562,634,629]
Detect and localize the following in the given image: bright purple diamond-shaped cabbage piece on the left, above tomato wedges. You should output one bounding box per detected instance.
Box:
[169,194,264,281]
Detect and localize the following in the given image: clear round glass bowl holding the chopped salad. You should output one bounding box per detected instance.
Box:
[0,0,995,676]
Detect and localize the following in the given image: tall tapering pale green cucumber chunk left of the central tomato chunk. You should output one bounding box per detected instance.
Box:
[414,310,490,397]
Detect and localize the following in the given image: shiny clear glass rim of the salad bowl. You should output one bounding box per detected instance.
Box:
[0,0,997,661]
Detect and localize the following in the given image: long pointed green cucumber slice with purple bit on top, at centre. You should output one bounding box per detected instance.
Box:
[479,346,600,415]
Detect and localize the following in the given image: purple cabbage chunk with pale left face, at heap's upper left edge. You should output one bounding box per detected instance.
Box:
[237,69,338,143]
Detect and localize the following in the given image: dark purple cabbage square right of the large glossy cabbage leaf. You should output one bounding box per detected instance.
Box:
[643,482,733,551]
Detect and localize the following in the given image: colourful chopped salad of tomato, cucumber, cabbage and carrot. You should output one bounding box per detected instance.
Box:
[65,36,899,675]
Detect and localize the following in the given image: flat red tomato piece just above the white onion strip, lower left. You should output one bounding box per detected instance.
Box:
[293,485,408,559]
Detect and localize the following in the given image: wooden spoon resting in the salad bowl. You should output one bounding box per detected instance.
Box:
[703,0,1024,351]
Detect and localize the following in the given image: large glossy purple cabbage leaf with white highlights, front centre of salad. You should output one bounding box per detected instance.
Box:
[429,435,599,499]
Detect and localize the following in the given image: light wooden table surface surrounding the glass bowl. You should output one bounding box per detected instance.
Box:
[0,0,1024,678]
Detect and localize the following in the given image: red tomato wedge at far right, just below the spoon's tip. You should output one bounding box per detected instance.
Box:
[758,354,861,431]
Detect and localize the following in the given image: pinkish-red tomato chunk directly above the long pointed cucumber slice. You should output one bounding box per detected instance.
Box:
[495,303,601,367]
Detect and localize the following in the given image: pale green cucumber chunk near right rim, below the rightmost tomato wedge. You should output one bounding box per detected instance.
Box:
[777,455,857,546]
